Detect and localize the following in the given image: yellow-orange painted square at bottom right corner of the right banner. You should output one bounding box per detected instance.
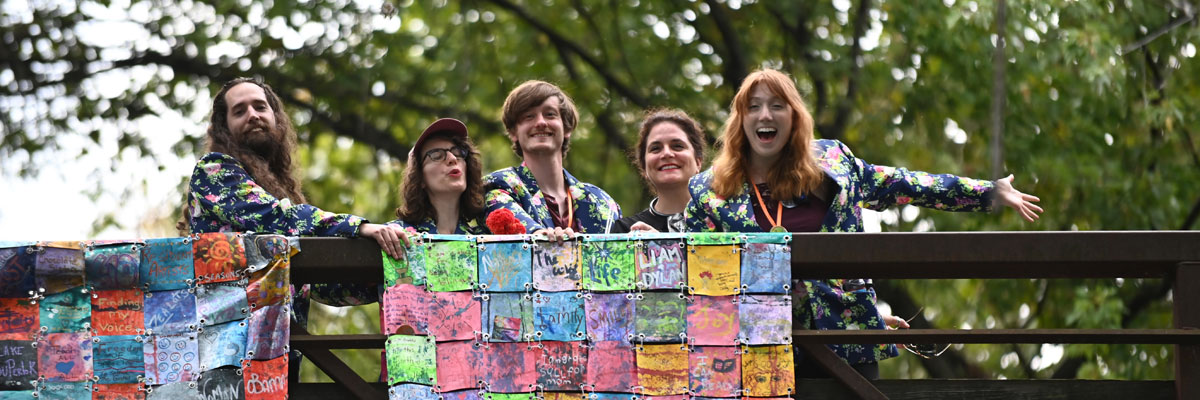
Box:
[742,345,796,396]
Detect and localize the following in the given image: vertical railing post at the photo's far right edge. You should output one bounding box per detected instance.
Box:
[1171,261,1200,399]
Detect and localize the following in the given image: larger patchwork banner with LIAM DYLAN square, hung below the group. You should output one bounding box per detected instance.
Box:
[382,233,796,400]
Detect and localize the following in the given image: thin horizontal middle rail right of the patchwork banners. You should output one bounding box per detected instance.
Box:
[792,329,1200,345]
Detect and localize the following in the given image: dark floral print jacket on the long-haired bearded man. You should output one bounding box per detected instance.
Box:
[187,153,366,237]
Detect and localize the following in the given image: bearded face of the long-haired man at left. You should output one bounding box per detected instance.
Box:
[226,82,282,150]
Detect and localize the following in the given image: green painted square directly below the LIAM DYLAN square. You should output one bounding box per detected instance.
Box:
[634,292,688,342]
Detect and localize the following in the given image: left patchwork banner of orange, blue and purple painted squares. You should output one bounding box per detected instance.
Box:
[0,233,299,400]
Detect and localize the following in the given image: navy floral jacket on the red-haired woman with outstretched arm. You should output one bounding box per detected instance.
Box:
[686,139,994,364]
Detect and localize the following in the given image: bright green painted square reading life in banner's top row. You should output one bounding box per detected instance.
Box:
[583,240,637,291]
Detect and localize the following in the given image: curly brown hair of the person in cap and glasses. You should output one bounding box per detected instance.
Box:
[396,132,484,223]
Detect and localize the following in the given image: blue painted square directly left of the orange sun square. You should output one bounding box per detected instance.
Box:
[140,238,196,291]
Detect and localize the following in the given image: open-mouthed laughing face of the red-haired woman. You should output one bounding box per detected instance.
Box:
[742,84,792,163]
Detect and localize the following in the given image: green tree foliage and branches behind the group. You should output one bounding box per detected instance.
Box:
[0,0,1200,377]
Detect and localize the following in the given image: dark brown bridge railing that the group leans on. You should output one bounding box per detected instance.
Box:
[290,231,1200,400]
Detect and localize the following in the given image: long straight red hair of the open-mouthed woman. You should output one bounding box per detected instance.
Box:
[713,70,824,198]
